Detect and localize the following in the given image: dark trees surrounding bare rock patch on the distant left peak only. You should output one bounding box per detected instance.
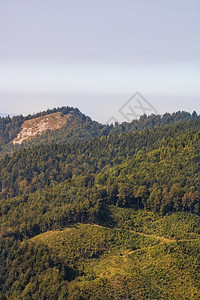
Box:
[0,107,107,156]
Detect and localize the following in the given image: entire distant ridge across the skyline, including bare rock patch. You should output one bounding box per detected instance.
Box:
[0,107,199,156]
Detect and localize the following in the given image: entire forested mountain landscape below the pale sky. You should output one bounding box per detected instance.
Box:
[0,108,200,299]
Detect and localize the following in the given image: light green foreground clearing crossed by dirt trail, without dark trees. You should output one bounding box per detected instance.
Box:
[31,220,200,299]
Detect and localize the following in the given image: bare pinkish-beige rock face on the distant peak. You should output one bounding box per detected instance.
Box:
[12,112,71,144]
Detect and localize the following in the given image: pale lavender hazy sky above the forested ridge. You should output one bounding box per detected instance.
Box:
[0,0,200,123]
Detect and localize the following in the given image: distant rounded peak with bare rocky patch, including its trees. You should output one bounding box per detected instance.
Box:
[0,107,106,155]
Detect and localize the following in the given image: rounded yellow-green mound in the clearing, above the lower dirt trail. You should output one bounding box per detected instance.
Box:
[31,224,159,267]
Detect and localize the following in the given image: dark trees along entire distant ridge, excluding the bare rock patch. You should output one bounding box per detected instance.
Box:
[0,107,199,156]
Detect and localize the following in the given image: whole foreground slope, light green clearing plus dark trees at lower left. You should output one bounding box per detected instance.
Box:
[3,207,200,300]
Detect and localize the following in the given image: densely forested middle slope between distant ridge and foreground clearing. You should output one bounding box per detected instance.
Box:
[0,116,200,237]
